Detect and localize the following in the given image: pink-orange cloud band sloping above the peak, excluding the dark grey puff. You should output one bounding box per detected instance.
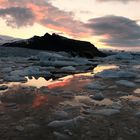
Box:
[0,0,90,37]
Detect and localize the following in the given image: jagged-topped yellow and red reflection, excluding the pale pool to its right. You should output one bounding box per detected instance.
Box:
[24,73,93,89]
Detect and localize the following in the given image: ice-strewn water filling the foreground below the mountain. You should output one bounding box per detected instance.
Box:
[0,49,140,140]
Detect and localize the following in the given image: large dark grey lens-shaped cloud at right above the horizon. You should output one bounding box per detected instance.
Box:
[85,15,140,47]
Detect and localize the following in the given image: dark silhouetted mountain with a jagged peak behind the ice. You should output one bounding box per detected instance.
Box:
[3,33,105,58]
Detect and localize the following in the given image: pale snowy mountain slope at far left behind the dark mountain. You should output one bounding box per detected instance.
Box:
[0,35,21,45]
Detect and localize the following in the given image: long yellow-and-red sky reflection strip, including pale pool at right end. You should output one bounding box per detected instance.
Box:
[2,64,119,89]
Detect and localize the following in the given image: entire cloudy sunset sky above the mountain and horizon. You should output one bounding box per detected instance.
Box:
[0,0,140,50]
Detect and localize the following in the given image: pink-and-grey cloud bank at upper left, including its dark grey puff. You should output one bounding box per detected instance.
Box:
[0,0,87,37]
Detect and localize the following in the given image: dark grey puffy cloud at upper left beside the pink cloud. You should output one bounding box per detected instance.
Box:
[0,7,35,27]
